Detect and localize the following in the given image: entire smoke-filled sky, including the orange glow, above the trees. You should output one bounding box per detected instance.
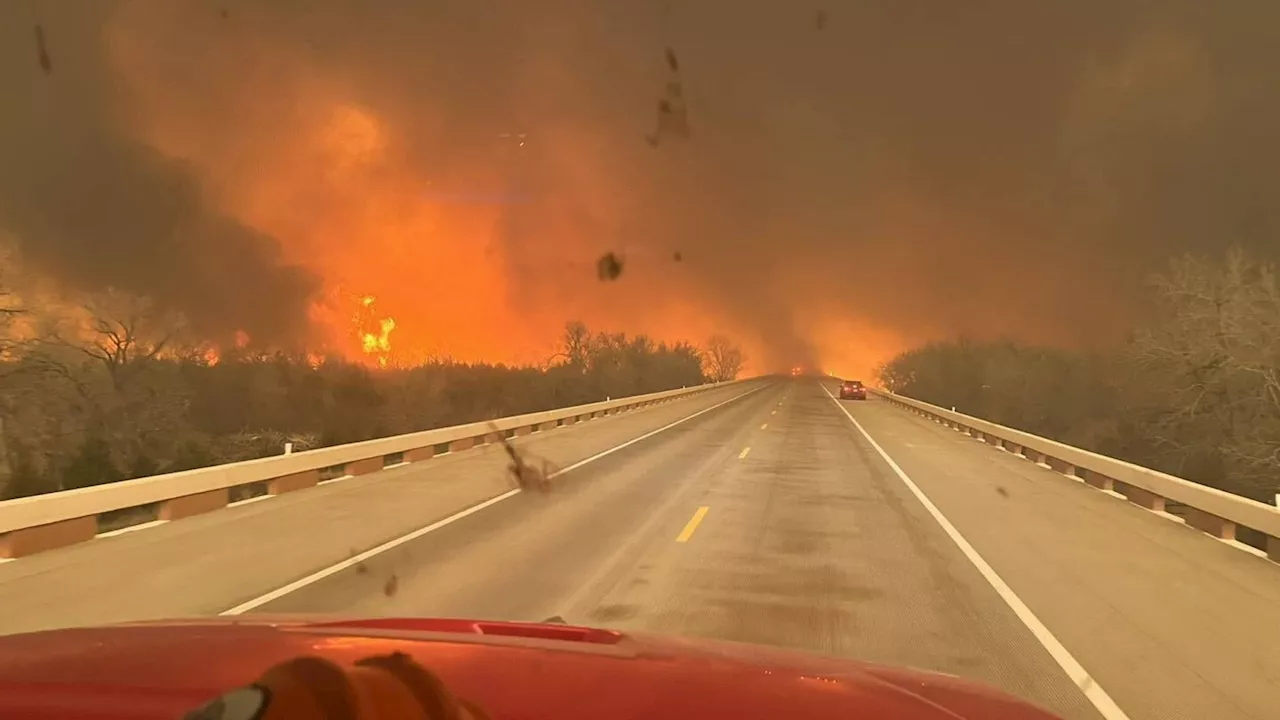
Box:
[0,0,1259,377]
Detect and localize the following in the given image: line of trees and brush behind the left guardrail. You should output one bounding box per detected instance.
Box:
[0,283,744,500]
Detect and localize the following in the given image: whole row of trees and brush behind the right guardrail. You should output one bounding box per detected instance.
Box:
[879,251,1280,503]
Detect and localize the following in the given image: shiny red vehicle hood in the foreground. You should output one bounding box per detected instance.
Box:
[0,609,1055,720]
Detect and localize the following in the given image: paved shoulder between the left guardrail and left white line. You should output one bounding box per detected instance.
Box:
[0,382,767,634]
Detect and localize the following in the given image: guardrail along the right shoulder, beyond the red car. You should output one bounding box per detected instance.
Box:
[868,388,1280,562]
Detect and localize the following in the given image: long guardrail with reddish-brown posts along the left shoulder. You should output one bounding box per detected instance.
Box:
[0,379,750,559]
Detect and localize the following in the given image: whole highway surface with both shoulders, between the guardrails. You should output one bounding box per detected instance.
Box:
[0,378,1280,720]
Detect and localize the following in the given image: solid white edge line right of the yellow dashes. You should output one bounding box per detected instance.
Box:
[822,387,1129,720]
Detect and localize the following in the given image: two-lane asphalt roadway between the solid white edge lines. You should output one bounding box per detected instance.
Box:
[261,380,1097,719]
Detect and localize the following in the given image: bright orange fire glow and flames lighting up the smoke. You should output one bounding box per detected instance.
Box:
[99,3,916,370]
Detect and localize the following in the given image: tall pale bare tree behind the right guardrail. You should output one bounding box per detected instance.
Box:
[1132,250,1280,493]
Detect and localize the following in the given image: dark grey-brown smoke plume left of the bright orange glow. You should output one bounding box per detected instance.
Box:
[0,3,317,342]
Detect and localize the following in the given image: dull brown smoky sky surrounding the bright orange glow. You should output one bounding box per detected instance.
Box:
[0,0,1280,366]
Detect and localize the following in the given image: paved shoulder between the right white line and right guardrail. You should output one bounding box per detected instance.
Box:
[852,384,1280,720]
